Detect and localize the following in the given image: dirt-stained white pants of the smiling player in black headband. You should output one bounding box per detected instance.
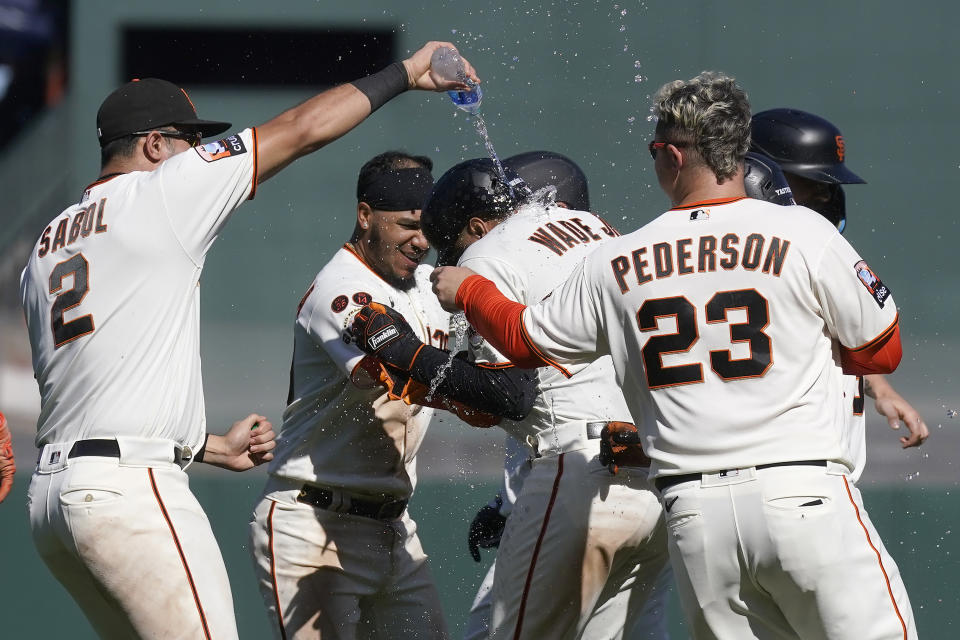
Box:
[244,482,448,640]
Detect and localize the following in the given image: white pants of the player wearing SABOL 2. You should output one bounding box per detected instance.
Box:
[28,438,237,640]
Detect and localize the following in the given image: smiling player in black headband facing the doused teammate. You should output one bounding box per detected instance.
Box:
[250,152,449,640]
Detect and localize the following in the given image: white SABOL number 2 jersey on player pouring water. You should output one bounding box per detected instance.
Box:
[20,129,257,450]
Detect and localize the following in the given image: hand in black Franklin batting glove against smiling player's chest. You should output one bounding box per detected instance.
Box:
[350,302,423,371]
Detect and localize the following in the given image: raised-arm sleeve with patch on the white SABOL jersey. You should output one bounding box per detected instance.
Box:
[155,129,257,264]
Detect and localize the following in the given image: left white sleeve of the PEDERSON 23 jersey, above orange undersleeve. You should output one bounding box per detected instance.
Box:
[523,253,609,376]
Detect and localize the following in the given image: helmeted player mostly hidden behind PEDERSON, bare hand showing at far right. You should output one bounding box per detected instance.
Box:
[750,108,930,450]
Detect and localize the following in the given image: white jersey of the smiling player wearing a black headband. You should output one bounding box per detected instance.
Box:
[269,245,449,499]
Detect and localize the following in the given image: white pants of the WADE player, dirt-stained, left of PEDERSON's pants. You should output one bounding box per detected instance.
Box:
[490,448,667,640]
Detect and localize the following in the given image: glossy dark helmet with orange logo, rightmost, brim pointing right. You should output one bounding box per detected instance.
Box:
[750,109,866,184]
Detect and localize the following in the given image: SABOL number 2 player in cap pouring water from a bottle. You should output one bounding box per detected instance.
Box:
[21,42,484,638]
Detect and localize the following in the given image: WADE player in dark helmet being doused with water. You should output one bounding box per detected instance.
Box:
[353,159,667,638]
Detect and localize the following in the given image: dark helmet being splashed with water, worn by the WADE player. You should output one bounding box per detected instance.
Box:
[420,158,530,265]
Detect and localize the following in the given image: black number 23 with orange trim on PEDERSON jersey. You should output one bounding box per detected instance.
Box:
[637,289,771,389]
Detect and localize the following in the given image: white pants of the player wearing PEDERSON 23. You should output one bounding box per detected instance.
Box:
[661,463,917,640]
